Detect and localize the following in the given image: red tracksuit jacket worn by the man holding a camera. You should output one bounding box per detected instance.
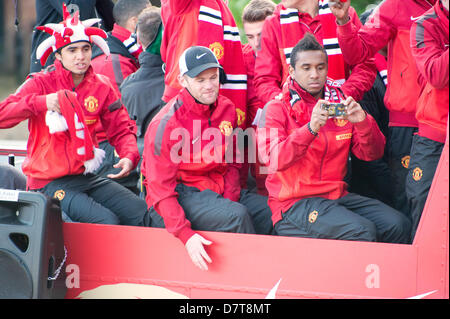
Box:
[257,78,385,225]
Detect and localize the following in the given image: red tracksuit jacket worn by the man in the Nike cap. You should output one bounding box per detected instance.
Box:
[142,89,240,243]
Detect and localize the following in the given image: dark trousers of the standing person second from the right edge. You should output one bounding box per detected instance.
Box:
[386,127,417,218]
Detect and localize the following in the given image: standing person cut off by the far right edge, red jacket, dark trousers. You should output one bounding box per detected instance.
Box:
[406,0,449,238]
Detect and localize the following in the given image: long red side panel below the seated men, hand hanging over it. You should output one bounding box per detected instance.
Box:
[64,224,417,298]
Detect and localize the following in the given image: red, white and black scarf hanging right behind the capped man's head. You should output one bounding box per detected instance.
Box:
[197,0,247,125]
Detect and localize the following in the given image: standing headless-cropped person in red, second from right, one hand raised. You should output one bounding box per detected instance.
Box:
[330,0,436,216]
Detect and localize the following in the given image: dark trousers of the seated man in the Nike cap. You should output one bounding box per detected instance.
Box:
[150,184,272,235]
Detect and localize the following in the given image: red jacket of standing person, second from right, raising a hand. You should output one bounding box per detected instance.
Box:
[338,0,436,127]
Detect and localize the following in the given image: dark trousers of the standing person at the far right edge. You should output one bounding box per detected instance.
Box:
[406,135,444,240]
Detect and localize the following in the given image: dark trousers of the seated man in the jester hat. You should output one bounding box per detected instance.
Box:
[39,174,150,226]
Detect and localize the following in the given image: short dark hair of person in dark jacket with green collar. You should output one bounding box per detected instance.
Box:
[137,6,162,48]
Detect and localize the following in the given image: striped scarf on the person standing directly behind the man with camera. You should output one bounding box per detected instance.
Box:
[280,0,346,85]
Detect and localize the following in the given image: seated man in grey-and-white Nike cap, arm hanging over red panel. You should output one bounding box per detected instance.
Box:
[142,46,272,270]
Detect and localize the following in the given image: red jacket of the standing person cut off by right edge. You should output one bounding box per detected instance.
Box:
[411,1,449,143]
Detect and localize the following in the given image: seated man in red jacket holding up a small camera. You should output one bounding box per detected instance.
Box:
[257,35,411,243]
